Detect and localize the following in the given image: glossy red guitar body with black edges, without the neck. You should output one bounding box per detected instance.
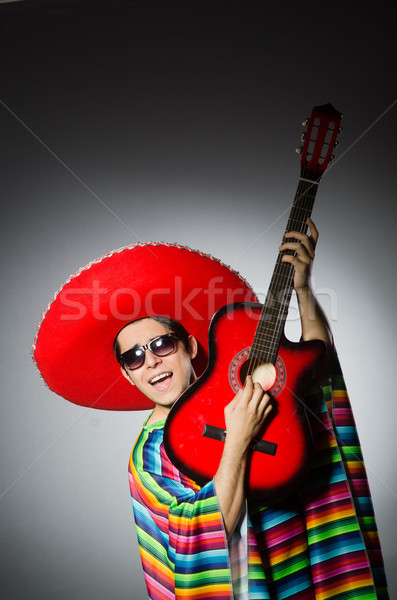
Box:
[164,303,325,499]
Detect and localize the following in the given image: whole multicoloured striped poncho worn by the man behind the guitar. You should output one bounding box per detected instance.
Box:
[130,356,389,600]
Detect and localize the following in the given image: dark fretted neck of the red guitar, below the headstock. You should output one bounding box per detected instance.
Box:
[250,171,321,364]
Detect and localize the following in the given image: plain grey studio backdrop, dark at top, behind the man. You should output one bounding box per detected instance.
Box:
[0,0,397,599]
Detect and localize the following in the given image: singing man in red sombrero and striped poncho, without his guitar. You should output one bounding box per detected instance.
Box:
[34,227,387,600]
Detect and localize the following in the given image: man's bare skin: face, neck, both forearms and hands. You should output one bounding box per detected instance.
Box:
[116,219,332,538]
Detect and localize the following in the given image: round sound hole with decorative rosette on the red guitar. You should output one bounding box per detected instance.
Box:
[229,348,286,397]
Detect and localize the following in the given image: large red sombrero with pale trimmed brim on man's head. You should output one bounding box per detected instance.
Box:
[32,243,256,410]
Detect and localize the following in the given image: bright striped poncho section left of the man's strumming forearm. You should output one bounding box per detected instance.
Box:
[130,421,232,600]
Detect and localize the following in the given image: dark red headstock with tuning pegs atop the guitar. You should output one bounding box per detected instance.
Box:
[297,104,342,180]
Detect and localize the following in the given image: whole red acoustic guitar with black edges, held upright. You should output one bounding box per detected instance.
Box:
[164,104,342,499]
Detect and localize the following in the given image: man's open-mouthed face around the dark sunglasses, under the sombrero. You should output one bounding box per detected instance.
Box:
[117,318,197,409]
